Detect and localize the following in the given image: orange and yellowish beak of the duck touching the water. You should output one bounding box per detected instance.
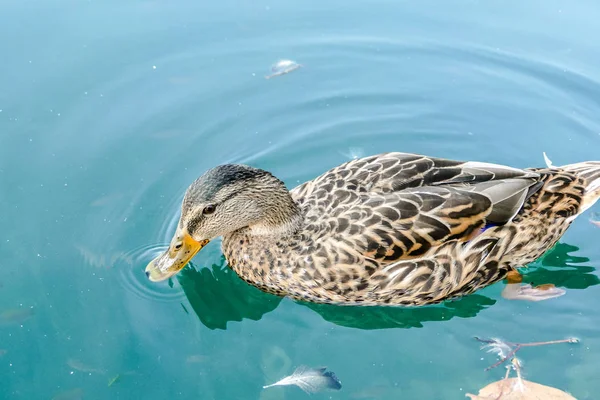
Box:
[146,232,209,282]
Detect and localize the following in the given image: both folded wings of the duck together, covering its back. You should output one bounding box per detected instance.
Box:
[302,153,539,264]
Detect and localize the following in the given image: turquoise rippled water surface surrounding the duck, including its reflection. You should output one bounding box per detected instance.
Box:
[0,0,600,400]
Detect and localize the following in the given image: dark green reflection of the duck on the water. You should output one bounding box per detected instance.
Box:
[178,243,600,329]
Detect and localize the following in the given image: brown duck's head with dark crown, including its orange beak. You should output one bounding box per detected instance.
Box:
[146,164,299,282]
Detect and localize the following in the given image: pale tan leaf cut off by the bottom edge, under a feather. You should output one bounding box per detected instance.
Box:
[466,378,576,400]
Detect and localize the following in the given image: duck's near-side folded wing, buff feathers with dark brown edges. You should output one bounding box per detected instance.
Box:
[326,179,535,264]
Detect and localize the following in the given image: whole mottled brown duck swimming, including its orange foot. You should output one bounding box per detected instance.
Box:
[146,152,600,306]
